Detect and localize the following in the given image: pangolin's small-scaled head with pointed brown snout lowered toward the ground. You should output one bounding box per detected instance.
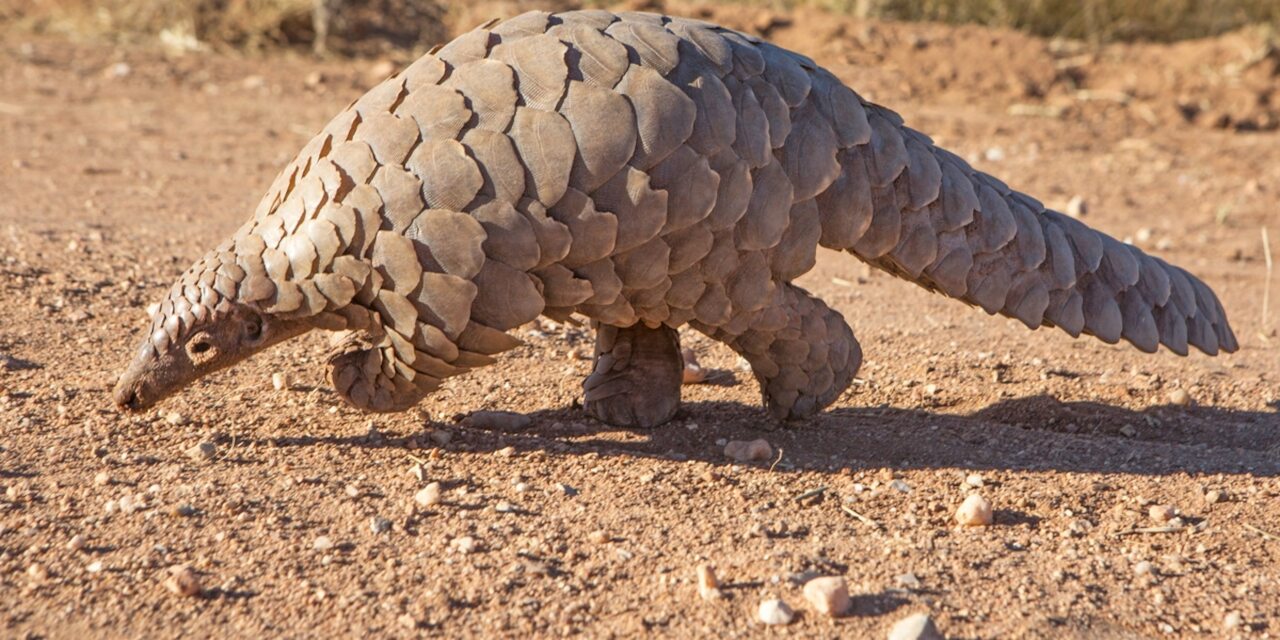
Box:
[114,253,310,411]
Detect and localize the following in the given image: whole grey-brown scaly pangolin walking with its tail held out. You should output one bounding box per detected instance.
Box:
[115,10,1236,426]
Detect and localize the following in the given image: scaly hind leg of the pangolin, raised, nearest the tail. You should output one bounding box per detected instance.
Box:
[703,283,863,420]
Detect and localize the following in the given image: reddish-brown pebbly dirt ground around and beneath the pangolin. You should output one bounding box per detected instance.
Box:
[0,6,1280,639]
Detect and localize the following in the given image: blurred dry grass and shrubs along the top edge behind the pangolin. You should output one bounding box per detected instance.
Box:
[0,0,1280,54]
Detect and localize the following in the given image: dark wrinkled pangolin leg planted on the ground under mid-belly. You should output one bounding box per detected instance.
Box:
[582,323,684,428]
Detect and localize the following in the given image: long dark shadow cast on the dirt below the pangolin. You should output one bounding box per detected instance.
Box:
[254,396,1280,476]
